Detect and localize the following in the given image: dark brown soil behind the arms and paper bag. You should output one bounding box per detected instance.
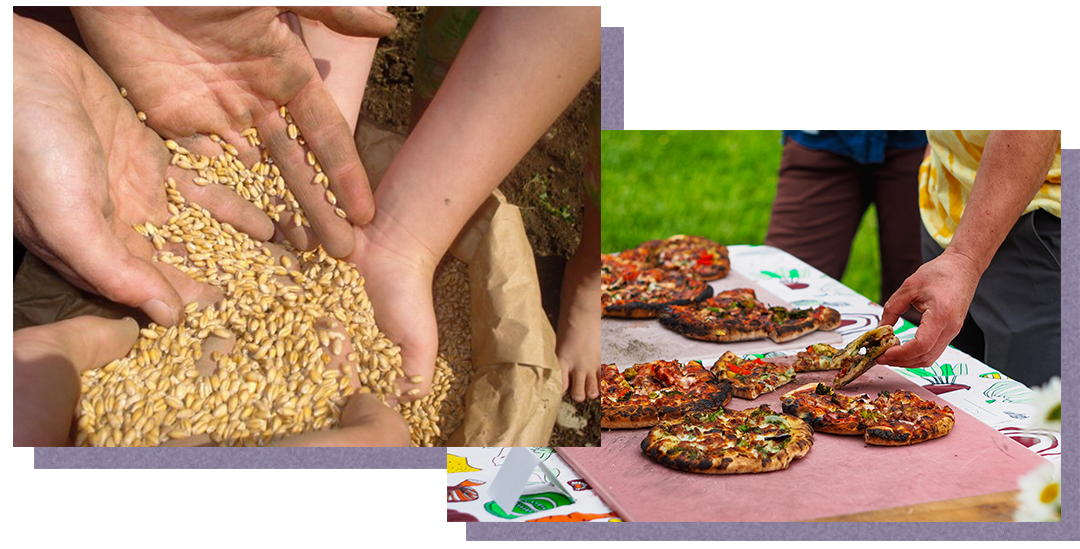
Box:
[361,8,599,446]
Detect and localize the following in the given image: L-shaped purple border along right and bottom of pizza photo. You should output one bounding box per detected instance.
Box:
[465,149,1080,540]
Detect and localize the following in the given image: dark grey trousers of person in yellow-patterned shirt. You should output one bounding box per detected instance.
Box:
[922,210,1062,387]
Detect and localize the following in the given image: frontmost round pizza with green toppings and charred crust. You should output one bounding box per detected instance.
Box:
[642,405,813,474]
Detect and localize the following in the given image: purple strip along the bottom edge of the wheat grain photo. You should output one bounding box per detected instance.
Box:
[33,447,446,469]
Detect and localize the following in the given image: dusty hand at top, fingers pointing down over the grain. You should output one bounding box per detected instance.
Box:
[72,6,396,257]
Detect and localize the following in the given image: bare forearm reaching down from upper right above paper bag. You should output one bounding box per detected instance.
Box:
[374,8,600,257]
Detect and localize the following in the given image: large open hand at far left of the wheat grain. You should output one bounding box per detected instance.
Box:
[13,15,253,325]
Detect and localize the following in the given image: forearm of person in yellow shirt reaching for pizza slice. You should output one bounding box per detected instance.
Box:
[945,130,1061,272]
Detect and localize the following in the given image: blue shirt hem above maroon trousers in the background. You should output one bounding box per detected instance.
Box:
[781,130,927,164]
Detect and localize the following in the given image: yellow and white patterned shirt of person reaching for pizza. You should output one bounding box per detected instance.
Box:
[919,130,1062,247]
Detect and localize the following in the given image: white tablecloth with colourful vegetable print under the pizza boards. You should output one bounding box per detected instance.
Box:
[446,245,1062,522]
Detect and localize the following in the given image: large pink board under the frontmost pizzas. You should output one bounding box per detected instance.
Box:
[558,366,1045,522]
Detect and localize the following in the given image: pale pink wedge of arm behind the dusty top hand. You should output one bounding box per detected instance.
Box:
[299,17,379,134]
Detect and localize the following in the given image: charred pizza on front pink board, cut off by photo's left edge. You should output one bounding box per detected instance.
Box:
[600,360,731,429]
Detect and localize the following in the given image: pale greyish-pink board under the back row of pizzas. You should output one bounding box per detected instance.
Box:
[600,271,843,370]
